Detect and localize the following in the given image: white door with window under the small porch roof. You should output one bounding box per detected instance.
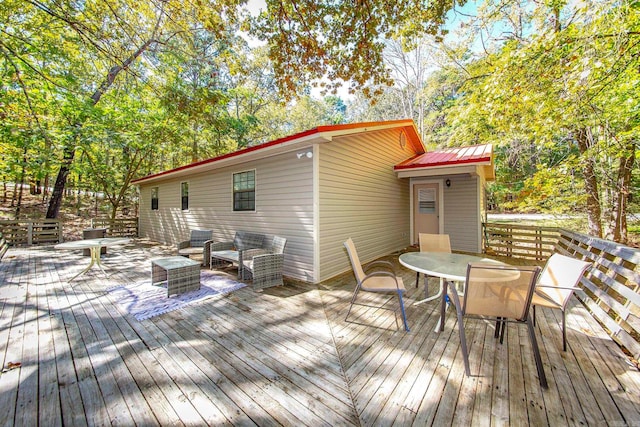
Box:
[413,183,440,243]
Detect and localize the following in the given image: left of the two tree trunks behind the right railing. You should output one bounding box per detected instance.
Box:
[574,128,602,237]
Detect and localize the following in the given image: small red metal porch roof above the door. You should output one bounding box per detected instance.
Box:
[394,144,493,170]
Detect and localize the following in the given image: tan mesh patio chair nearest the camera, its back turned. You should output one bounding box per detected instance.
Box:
[449,263,547,388]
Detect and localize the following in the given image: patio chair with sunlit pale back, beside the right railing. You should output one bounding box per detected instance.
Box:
[531,253,591,351]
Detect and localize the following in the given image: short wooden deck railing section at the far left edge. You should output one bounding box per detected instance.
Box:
[0,219,62,246]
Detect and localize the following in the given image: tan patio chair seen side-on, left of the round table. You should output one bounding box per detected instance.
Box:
[344,238,409,332]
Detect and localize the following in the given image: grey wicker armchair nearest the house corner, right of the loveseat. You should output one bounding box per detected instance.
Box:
[242,236,287,290]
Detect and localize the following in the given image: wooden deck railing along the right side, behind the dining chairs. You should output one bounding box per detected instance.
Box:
[484,223,640,360]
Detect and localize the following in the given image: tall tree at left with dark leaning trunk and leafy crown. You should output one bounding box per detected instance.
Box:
[2,0,245,218]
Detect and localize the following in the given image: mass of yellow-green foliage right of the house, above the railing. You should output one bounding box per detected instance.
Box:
[402,0,640,239]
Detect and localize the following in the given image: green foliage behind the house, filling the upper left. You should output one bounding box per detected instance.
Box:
[0,0,352,219]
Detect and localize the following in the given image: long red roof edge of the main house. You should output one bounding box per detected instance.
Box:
[132,119,424,184]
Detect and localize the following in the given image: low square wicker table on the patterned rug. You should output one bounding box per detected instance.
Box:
[151,256,200,297]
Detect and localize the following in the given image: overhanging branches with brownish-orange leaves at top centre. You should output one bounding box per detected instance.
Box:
[251,0,464,97]
